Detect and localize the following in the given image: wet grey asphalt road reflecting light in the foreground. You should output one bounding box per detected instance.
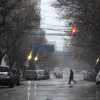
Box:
[0,79,96,100]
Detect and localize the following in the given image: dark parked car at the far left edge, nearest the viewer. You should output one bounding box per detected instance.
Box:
[0,66,20,87]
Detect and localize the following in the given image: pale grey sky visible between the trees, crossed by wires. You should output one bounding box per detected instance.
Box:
[41,0,66,51]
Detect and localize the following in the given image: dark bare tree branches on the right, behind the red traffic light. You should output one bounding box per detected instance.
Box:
[57,0,100,64]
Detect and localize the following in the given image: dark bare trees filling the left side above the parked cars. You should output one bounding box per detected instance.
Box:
[0,0,40,66]
